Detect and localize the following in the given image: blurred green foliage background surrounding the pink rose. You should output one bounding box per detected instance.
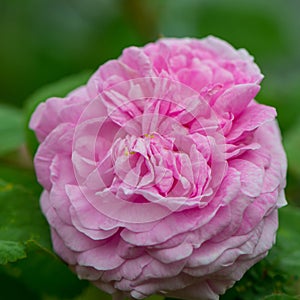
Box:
[0,0,300,300]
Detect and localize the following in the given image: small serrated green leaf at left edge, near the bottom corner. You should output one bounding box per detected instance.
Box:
[0,240,26,264]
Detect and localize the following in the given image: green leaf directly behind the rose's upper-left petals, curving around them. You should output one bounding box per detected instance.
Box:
[25,71,91,156]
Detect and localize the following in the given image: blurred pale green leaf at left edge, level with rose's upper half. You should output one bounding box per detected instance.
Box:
[0,105,24,155]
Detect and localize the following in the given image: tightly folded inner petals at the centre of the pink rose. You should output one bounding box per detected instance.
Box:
[110,133,210,206]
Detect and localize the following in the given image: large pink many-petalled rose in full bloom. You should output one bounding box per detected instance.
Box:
[30,37,286,299]
